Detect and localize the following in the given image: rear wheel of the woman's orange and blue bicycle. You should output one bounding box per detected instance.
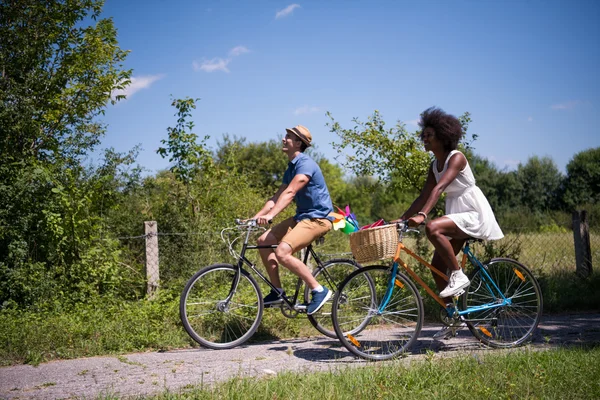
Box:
[462,258,543,348]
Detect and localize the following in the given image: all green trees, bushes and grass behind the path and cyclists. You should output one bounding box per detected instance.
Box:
[0,0,600,365]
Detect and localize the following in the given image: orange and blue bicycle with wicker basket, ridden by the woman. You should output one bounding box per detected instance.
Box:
[332,223,542,360]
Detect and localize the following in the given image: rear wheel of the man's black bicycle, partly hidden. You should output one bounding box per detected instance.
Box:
[304,259,366,339]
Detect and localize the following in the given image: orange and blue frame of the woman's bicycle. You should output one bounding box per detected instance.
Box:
[386,236,511,316]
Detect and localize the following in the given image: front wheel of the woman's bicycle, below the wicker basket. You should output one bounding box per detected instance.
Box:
[332,266,423,360]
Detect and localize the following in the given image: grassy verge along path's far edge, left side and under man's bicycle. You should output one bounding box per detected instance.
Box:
[0,290,318,366]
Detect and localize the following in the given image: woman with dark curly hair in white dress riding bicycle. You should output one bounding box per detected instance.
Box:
[400,107,504,298]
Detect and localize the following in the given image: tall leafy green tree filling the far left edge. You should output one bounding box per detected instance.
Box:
[0,0,131,305]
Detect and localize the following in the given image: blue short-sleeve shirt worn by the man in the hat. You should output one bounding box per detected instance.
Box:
[283,153,333,221]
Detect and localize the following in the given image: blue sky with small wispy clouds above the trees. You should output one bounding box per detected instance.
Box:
[102,0,600,173]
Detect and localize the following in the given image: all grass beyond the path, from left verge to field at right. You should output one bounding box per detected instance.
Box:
[0,233,600,366]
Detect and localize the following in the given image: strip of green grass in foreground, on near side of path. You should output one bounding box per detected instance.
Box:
[96,347,600,400]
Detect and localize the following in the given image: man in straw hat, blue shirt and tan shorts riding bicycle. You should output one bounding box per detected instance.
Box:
[253,125,333,315]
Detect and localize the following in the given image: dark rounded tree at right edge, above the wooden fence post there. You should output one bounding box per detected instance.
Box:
[563,147,600,209]
